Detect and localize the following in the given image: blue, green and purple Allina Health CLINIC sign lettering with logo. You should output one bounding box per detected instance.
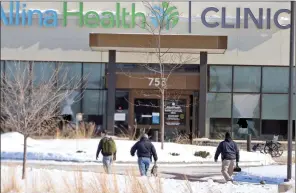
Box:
[1,1,291,29]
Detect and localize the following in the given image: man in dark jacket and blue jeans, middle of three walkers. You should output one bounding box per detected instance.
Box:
[131,134,158,176]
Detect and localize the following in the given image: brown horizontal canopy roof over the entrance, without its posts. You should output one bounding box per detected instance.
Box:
[89,33,227,54]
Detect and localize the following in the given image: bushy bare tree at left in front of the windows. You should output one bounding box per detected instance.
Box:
[1,62,83,179]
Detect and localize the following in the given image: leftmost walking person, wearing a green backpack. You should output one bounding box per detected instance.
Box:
[96,131,116,174]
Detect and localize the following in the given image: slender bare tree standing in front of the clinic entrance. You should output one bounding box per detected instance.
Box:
[119,2,197,149]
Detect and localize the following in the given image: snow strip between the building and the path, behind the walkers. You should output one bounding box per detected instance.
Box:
[1,132,274,165]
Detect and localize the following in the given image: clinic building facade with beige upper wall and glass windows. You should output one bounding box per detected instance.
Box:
[1,2,296,139]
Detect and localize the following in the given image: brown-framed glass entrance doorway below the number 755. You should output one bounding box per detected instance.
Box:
[129,90,196,139]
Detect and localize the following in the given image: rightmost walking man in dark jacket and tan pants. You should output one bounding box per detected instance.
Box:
[215,132,239,181]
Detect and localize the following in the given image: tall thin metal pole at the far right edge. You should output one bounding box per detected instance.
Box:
[287,1,296,181]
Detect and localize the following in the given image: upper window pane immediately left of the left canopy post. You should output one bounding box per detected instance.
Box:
[83,63,105,89]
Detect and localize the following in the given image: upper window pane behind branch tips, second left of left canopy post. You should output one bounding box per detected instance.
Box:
[58,62,82,89]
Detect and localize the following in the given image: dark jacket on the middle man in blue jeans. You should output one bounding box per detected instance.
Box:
[131,137,158,161]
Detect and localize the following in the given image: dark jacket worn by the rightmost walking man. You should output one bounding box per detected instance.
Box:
[214,138,239,162]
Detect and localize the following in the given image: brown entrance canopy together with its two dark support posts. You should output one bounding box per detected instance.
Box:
[89,33,228,137]
